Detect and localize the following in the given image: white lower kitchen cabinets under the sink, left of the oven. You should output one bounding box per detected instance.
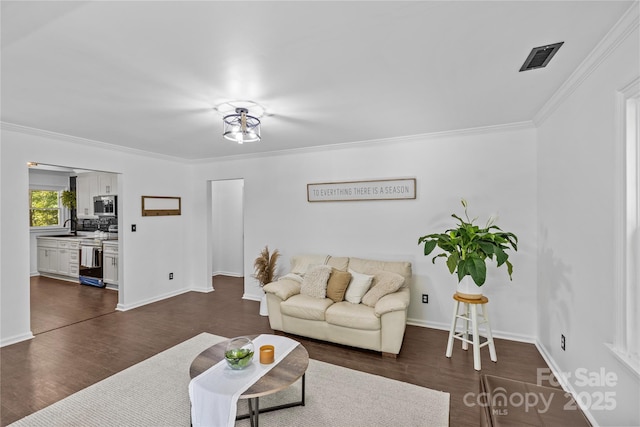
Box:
[38,237,80,280]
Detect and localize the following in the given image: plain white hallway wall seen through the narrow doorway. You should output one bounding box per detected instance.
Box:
[211,179,244,277]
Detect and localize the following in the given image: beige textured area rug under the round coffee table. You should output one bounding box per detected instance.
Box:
[11,333,449,427]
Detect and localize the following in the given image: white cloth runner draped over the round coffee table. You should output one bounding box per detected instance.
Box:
[189,334,298,427]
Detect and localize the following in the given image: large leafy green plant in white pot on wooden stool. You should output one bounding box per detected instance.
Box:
[418,199,518,298]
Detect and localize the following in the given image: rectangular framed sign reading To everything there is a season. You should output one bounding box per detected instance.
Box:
[307,178,416,202]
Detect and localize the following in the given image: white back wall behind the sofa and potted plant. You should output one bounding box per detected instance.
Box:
[193,125,537,341]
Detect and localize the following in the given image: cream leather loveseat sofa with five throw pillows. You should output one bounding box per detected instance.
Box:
[263,255,411,357]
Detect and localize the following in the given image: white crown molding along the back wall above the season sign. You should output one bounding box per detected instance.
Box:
[190,121,536,164]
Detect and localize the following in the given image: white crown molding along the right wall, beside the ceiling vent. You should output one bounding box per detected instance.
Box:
[533,2,640,126]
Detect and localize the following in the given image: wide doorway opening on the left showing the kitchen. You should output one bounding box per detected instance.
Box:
[27,163,123,335]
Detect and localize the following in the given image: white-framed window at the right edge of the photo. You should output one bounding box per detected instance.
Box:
[610,78,640,376]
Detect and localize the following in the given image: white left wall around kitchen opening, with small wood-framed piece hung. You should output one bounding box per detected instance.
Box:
[0,125,199,345]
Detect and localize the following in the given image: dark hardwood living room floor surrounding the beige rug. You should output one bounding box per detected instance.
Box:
[0,276,548,427]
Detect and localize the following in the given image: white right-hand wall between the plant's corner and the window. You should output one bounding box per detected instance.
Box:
[537,4,640,426]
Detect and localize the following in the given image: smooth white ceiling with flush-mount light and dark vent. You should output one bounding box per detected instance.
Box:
[0,0,633,160]
